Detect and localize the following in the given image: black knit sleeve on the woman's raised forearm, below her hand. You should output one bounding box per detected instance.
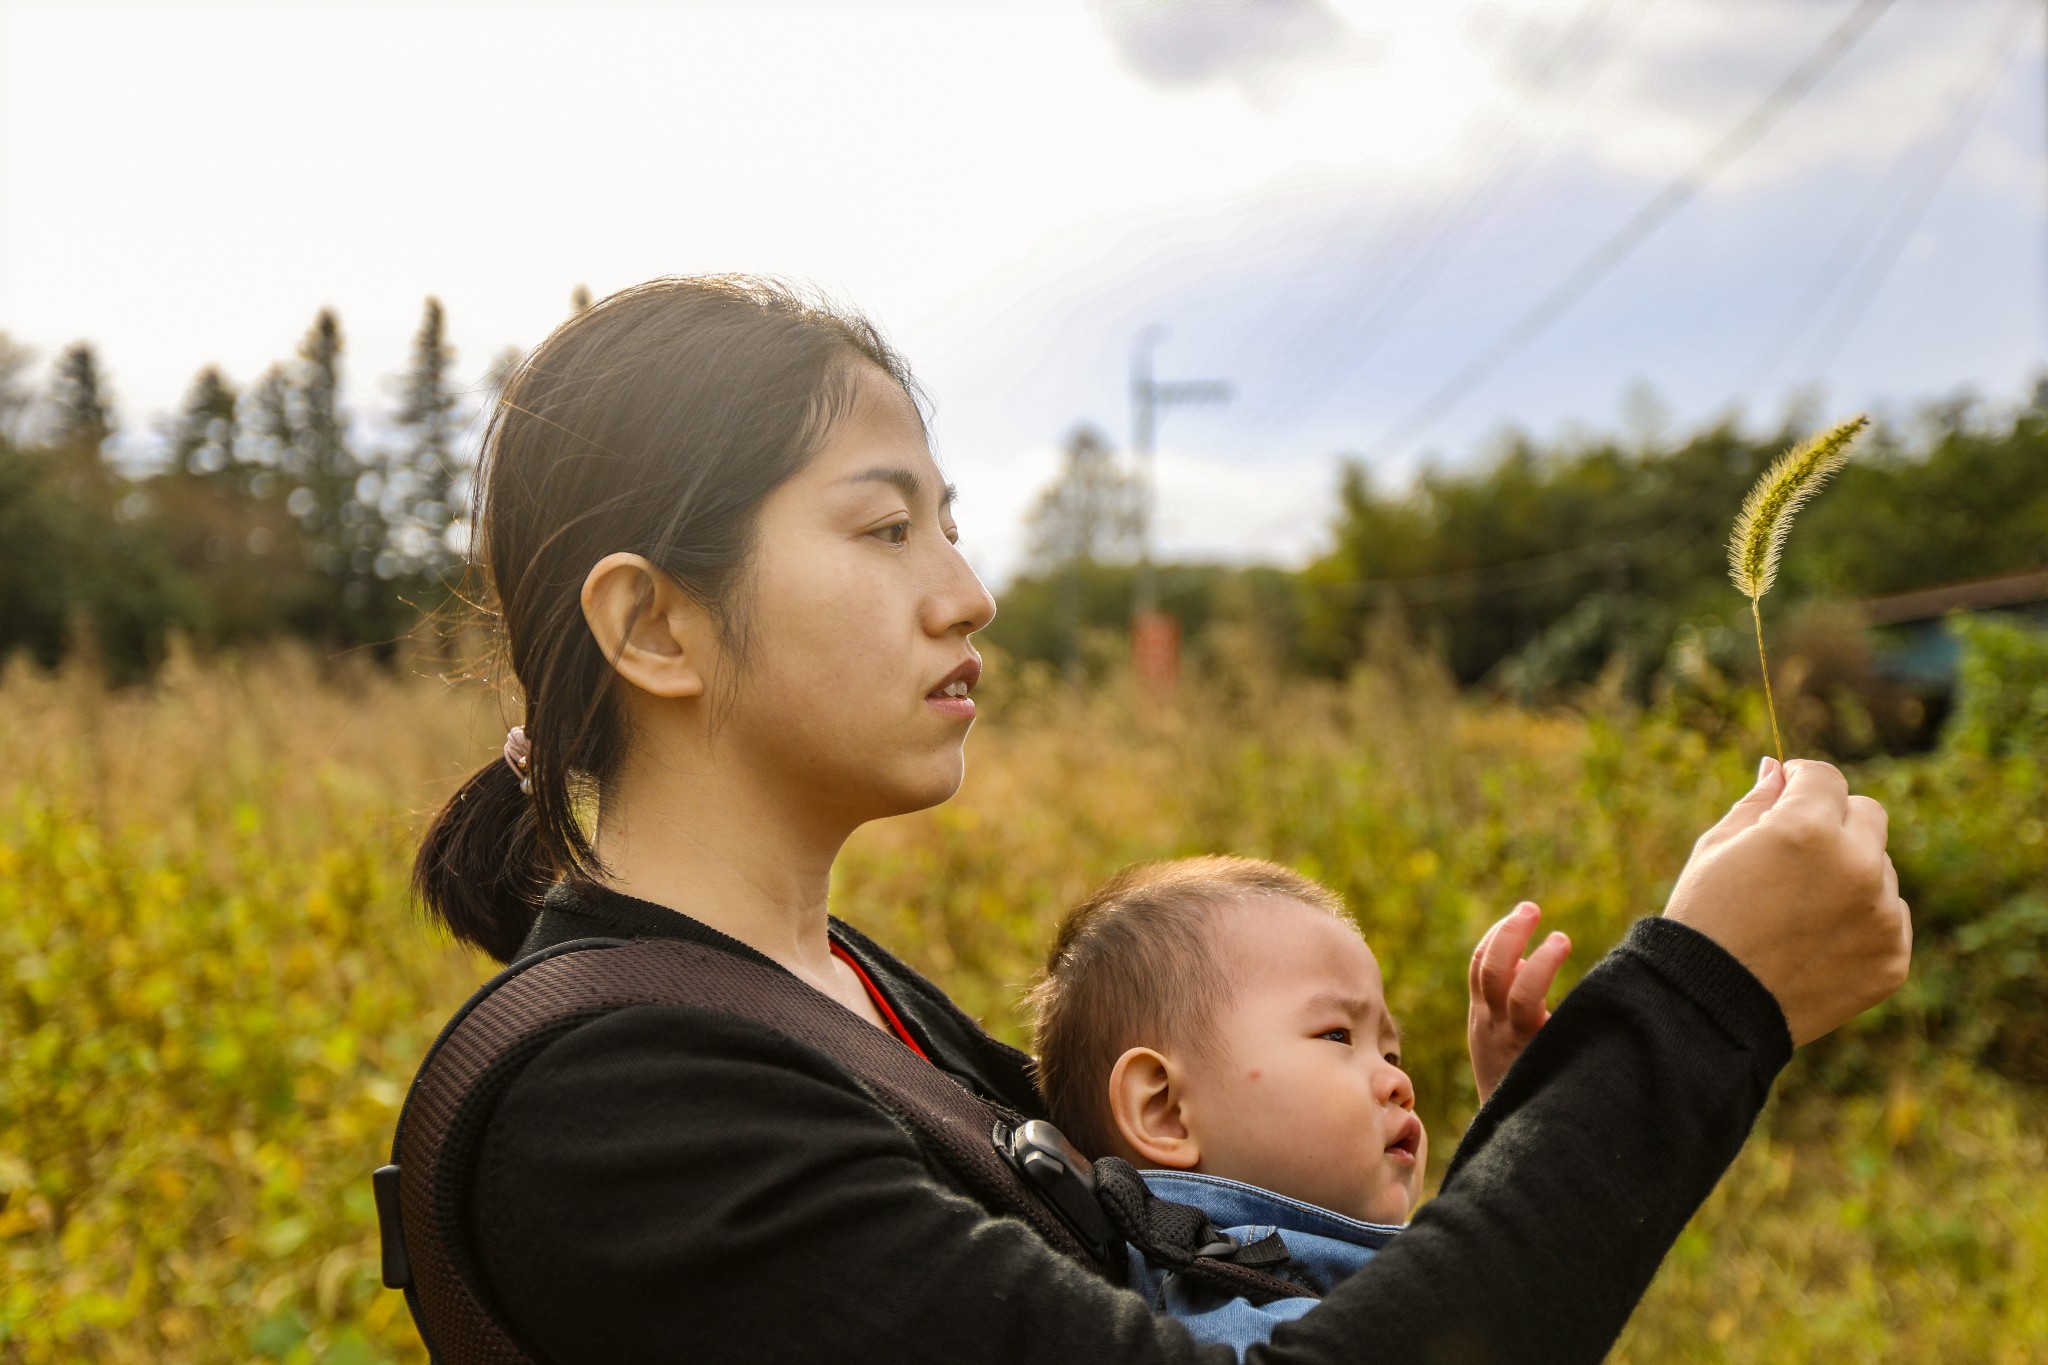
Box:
[1266,919,1792,1365]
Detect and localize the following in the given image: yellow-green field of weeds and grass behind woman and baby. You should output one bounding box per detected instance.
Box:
[0,649,2048,1363]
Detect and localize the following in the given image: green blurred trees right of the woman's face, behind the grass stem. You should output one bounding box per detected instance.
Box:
[989,379,2048,720]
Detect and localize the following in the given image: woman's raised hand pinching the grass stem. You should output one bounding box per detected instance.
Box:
[1665,759,1913,1046]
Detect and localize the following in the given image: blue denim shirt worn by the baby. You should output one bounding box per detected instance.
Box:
[1126,1171,1401,1361]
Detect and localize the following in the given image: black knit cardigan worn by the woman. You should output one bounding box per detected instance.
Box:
[471,888,1792,1365]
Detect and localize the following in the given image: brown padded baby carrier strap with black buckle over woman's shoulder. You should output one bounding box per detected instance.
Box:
[373,939,1309,1365]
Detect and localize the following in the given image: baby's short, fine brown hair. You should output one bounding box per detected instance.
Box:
[1026,857,1352,1156]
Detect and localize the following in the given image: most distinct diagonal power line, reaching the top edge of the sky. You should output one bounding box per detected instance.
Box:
[1368,0,1892,456]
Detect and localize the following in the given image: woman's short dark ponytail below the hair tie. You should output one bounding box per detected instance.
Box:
[412,759,555,962]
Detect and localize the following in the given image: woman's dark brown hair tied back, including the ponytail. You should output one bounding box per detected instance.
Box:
[412,276,922,962]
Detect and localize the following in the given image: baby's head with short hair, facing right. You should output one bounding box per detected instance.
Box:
[1032,857,1430,1224]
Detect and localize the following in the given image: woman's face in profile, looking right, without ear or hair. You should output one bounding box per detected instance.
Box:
[715,366,995,823]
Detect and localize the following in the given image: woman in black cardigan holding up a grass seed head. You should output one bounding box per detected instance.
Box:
[418,278,1909,1363]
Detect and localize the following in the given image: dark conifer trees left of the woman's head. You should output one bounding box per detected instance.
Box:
[0,299,512,677]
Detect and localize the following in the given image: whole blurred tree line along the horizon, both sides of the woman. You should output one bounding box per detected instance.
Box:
[0,291,2048,712]
